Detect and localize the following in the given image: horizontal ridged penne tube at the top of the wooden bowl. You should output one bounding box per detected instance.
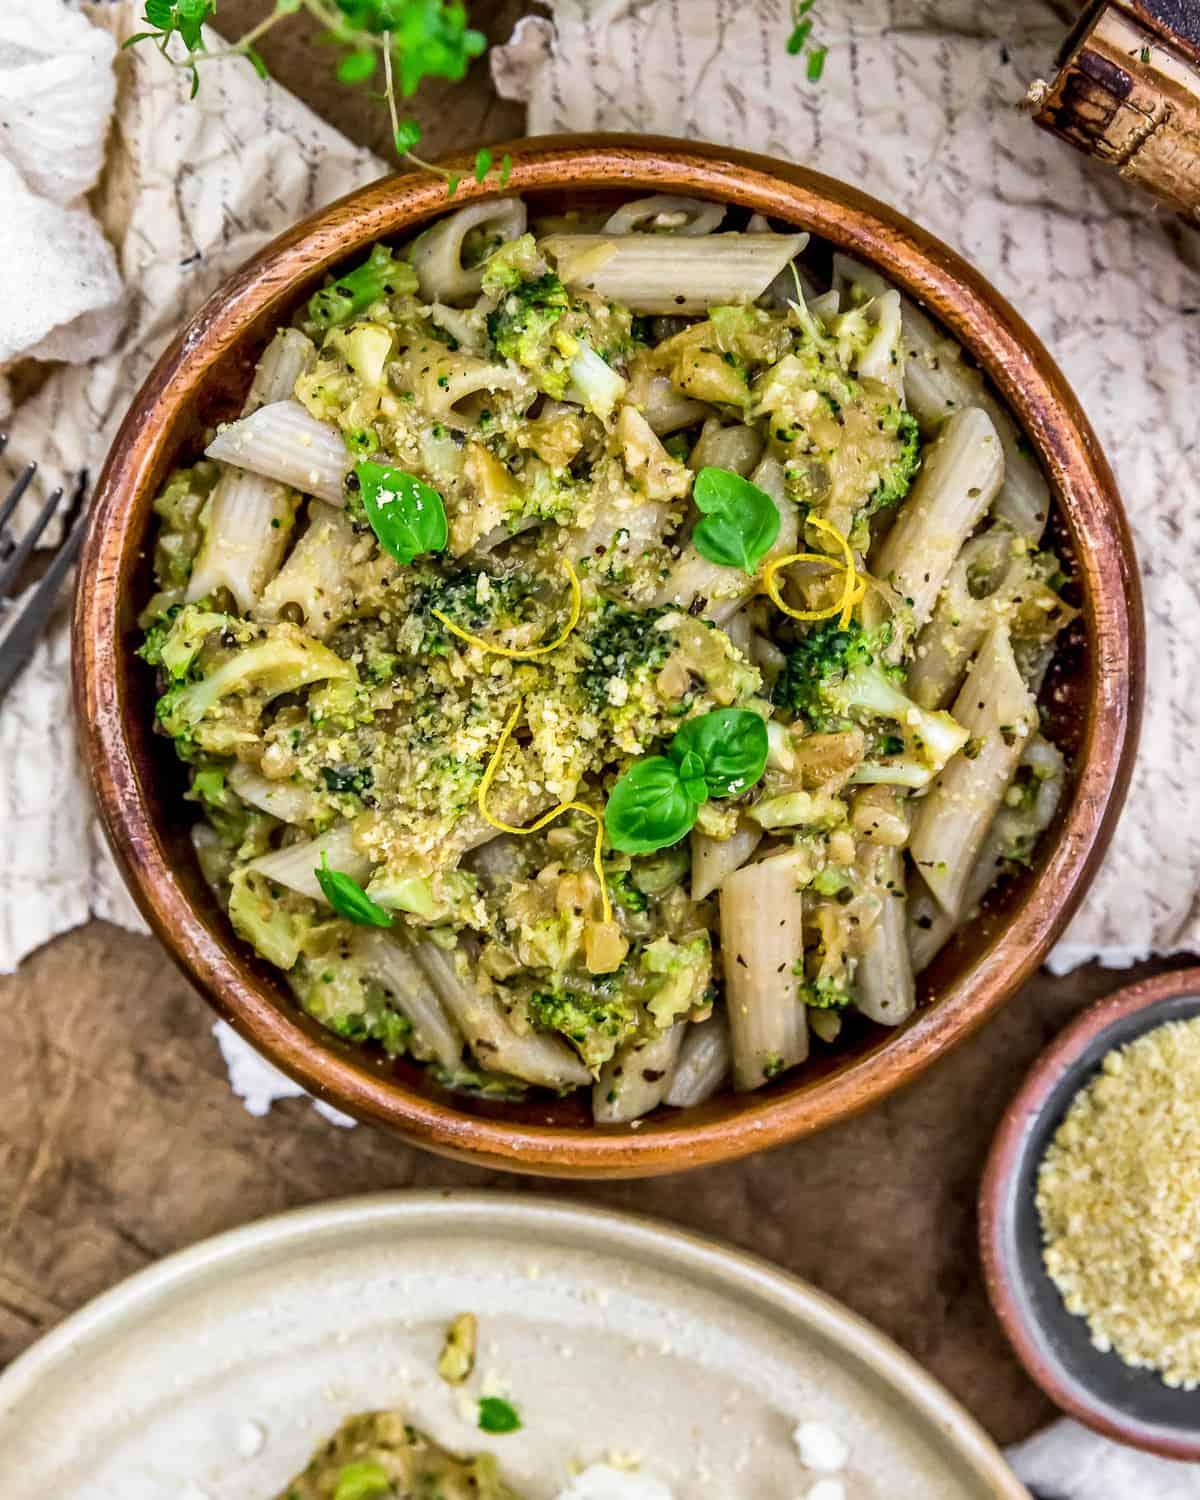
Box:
[542,234,809,315]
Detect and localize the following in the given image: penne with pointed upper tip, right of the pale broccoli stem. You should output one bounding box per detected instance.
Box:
[911,626,1038,918]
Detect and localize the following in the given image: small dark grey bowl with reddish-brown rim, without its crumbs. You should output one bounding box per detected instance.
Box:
[980,969,1200,1461]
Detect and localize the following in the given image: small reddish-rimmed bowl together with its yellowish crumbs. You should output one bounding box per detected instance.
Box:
[980,969,1200,1461]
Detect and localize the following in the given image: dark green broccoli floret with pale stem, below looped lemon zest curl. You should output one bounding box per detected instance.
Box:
[774,621,968,770]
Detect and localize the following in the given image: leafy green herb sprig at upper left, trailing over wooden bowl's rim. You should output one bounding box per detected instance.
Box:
[125,0,512,197]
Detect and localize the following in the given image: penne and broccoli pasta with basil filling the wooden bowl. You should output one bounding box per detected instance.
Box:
[141,197,1074,1124]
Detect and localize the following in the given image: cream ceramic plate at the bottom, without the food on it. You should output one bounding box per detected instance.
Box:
[0,1193,1028,1500]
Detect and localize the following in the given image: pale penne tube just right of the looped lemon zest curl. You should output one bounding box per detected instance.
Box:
[875,407,1004,657]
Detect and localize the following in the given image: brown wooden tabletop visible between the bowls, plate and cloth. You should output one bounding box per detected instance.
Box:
[0,0,1182,1442]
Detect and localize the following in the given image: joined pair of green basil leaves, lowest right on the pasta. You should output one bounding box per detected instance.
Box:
[605,708,767,854]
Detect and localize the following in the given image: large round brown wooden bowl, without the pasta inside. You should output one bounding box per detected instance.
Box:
[75,137,1143,1178]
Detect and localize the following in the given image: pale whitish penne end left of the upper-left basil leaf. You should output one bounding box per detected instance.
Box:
[204,401,351,506]
